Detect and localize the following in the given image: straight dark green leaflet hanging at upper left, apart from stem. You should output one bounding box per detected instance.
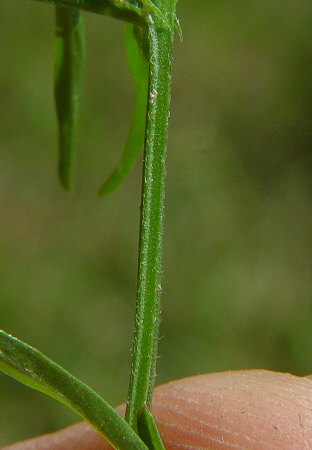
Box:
[54,5,84,190]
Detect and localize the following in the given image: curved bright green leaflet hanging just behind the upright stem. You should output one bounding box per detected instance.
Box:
[100,25,149,195]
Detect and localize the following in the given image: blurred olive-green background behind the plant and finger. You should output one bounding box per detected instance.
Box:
[0,0,312,446]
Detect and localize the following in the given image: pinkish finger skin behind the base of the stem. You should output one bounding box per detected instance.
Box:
[3,370,312,450]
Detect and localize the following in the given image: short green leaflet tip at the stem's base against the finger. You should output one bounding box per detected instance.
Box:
[137,405,166,450]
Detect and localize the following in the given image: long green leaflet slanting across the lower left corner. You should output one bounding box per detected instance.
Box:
[0,330,148,450]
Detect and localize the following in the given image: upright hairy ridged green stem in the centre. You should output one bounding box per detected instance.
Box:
[126,0,176,430]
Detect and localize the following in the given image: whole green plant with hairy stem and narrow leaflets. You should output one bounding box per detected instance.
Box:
[0,0,180,450]
